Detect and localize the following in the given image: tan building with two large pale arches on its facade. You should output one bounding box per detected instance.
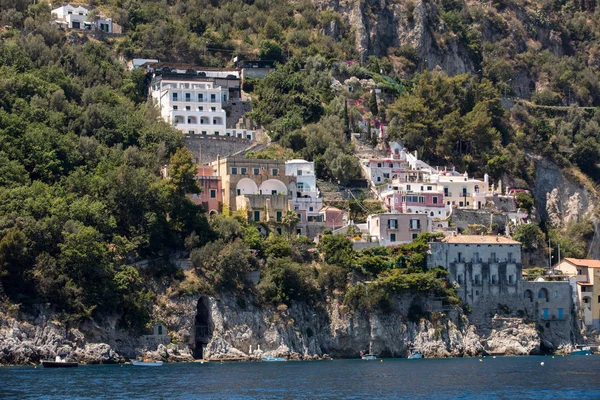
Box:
[213,157,297,222]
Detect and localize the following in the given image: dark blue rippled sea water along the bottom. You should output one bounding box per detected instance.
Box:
[0,355,600,399]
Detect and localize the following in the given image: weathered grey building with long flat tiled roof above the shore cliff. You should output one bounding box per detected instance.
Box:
[427,235,522,304]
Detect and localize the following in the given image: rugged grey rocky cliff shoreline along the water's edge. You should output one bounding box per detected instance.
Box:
[0,296,572,365]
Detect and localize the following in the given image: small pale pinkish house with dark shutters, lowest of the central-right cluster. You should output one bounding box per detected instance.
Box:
[367,213,430,246]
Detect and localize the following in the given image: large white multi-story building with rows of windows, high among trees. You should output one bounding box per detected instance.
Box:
[150,73,254,140]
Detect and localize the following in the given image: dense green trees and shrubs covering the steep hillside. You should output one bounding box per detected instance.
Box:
[0,0,600,328]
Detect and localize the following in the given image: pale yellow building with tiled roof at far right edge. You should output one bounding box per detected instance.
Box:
[556,258,600,329]
